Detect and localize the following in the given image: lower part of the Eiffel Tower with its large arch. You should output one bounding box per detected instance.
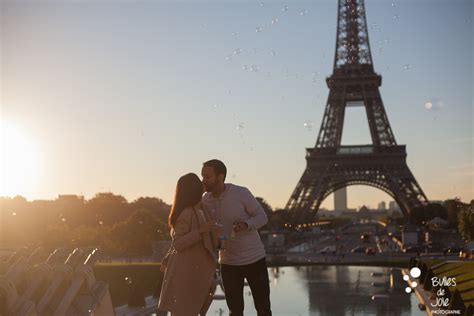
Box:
[286,145,428,223]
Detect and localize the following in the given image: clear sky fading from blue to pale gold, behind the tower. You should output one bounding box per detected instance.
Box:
[0,0,474,209]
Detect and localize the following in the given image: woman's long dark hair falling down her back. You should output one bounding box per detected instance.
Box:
[168,173,203,227]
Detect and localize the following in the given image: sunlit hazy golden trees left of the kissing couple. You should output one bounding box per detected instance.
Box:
[0,193,170,255]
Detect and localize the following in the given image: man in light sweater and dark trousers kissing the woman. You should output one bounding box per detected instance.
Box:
[201,159,272,316]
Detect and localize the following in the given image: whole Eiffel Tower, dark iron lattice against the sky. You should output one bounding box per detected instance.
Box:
[286,0,428,224]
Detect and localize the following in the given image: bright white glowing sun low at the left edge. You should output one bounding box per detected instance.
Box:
[0,119,40,197]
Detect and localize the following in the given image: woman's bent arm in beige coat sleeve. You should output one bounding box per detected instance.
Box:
[173,208,201,252]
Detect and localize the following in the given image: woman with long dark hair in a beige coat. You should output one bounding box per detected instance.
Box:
[158,173,218,316]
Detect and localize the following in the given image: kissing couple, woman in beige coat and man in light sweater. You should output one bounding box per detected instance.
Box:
[158,159,271,316]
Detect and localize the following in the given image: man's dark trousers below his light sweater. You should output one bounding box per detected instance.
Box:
[221,258,272,316]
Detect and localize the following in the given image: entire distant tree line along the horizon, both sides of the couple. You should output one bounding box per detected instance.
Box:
[0,193,474,256]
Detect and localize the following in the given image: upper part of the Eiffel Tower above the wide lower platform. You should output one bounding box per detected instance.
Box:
[316,0,397,148]
